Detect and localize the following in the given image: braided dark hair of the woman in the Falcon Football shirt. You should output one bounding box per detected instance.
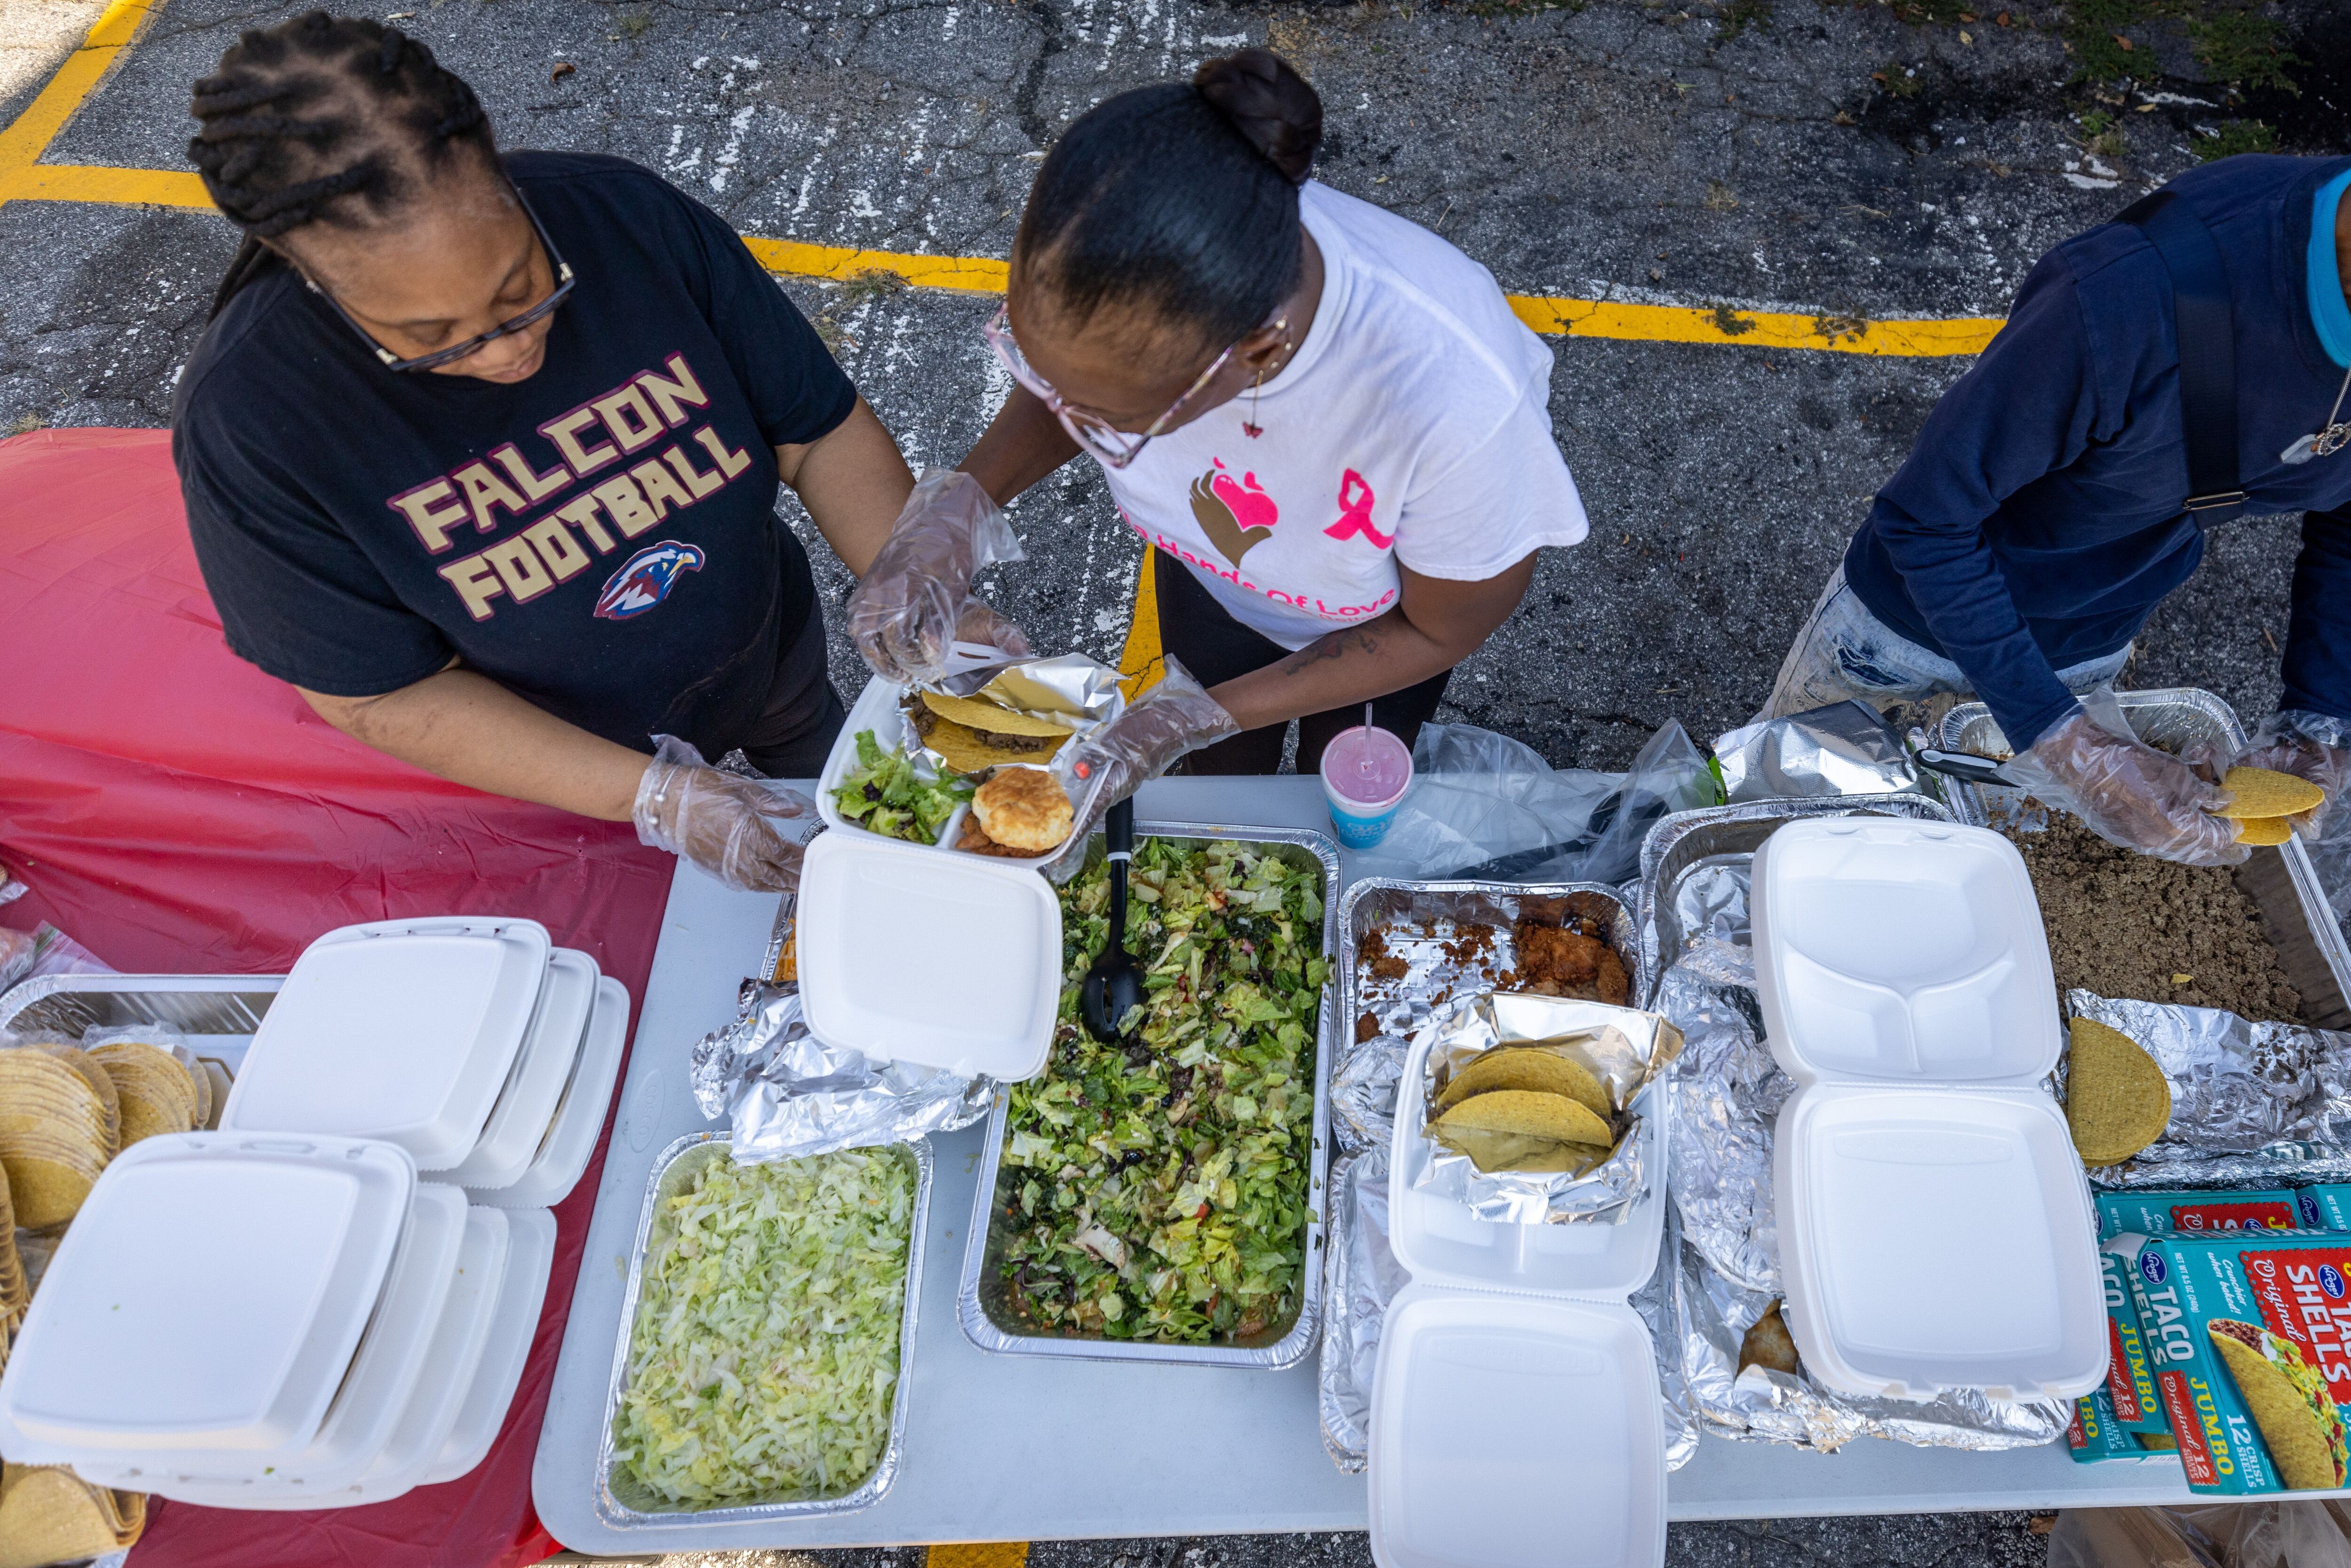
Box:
[188,12,498,315]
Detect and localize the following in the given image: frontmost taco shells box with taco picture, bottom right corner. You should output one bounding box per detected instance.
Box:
[2130,1232,2351,1495]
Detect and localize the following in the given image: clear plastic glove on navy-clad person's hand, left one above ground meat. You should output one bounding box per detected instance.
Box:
[2005,712,2252,865]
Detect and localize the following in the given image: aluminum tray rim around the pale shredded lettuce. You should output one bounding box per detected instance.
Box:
[595,1133,933,1530]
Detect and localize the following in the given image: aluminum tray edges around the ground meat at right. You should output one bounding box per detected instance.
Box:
[1940,686,2351,1030]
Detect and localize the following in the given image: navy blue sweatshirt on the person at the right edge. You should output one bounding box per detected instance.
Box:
[1846,158,2351,750]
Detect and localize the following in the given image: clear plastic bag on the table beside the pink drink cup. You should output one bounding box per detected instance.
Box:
[1359,719,1716,882]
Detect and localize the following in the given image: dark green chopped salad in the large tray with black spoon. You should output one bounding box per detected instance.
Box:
[999,839,1326,1345]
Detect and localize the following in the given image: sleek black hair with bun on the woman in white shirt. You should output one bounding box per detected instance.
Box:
[1018,49,1321,346]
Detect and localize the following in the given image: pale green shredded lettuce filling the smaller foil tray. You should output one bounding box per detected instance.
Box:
[614,1150,915,1509]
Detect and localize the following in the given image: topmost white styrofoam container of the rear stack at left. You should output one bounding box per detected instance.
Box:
[221,917,550,1171]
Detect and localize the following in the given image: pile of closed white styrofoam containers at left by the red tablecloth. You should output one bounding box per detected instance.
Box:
[0,917,628,1509]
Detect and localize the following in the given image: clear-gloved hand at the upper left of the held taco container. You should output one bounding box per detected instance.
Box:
[849,468,1030,686]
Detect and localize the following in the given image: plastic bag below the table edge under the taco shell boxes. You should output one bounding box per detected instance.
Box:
[2048,1500,2351,1568]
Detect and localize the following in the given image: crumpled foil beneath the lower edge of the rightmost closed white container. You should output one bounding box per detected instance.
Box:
[1674,1241,2074,1453]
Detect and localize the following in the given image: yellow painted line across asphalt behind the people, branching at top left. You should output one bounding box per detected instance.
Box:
[0,0,2001,360]
